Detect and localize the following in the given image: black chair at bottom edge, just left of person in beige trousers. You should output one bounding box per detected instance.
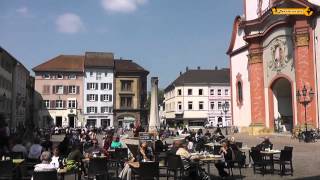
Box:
[87,157,108,179]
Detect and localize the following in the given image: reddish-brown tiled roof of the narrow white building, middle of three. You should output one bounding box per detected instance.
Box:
[84,52,114,68]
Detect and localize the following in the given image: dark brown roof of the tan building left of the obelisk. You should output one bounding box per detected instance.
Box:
[115,60,149,73]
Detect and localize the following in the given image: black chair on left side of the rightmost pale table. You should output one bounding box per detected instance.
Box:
[249,148,272,175]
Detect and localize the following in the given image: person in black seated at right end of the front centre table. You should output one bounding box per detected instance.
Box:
[215,141,235,177]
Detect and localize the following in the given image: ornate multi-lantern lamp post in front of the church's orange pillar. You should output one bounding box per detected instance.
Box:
[297,85,314,134]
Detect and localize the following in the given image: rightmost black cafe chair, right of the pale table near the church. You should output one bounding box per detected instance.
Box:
[275,148,293,176]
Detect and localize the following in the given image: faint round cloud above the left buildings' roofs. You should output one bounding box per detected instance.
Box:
[56,13,84,34]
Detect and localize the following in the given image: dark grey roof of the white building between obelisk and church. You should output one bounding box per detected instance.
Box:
[166,69,230,90]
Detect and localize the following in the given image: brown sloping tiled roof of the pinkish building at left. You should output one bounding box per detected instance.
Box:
[32,55,84,72]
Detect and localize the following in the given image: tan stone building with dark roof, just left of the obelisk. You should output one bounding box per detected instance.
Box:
[114,59,149,127]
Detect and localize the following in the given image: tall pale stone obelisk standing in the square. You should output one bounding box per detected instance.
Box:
[149,77,160,133]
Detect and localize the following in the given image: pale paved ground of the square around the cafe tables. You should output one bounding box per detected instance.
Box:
[53,134,320,180]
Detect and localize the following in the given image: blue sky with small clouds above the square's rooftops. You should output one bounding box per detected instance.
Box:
[0,0,243,88]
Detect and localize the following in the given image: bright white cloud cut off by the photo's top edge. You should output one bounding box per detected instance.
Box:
[101,0,148,13]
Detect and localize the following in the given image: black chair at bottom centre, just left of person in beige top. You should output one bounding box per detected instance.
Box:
[167,155,184,180]
